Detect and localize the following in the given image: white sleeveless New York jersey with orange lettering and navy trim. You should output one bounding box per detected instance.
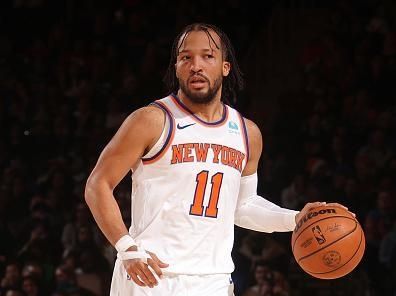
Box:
[130,95,248,274]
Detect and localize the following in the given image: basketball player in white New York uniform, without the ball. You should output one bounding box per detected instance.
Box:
[85,24,350,296]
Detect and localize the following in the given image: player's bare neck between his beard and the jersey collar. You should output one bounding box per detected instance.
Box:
[177,89,224,122]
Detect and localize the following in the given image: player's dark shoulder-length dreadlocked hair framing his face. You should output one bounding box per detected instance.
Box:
[164,23,244,104]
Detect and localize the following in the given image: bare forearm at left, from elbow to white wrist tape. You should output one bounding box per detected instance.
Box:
[85,181,128,246]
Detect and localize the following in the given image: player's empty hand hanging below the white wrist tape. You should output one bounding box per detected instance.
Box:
[123,246,169,288]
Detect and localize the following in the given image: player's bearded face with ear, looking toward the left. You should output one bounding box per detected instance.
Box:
[175,30,230,104]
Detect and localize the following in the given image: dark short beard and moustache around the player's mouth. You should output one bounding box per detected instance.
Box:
[179,75,223,105]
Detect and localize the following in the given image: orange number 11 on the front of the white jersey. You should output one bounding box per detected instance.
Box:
[190,171,223,218]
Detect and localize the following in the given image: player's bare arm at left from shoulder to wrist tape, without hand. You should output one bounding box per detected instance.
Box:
[85,106,165,246]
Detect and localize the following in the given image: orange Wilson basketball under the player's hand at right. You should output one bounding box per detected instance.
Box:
[291,206,366,279]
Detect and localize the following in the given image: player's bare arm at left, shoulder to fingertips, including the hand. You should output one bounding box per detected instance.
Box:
[85,106,168,288]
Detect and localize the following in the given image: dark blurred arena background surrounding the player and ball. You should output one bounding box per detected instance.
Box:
[0,0,396,296]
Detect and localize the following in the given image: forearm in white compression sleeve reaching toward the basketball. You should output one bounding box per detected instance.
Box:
[235,195,298,232]
